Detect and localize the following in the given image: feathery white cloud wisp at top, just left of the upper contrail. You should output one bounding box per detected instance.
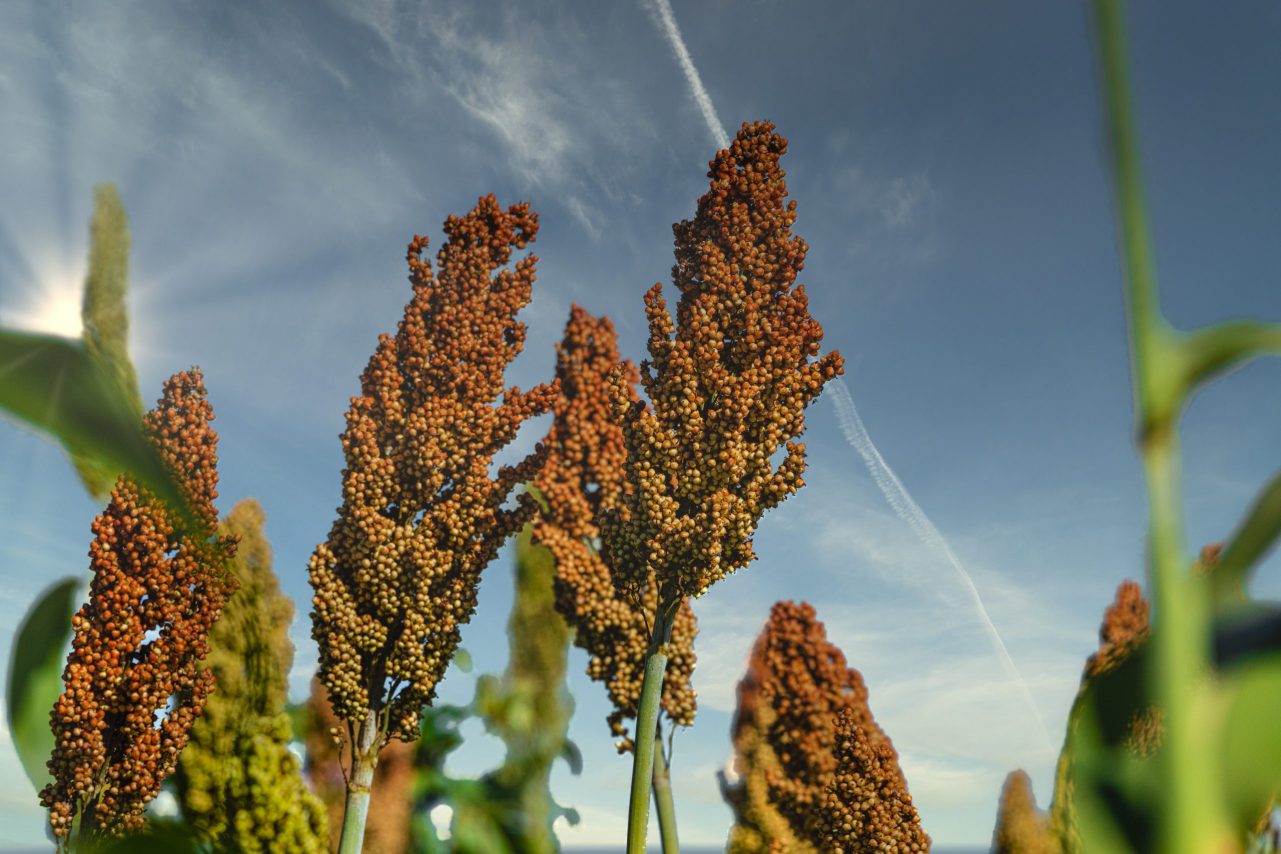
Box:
[336,0,655,238]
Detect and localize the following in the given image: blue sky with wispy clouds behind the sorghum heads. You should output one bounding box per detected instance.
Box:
[0,0,1281,849]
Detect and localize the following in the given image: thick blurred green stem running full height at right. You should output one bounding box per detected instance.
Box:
[1095,0,1231,854]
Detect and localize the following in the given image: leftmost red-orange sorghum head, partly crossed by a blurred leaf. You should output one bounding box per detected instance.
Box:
[40,369,236,848]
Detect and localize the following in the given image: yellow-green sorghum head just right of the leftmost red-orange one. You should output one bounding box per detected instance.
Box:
[174,499,329,854]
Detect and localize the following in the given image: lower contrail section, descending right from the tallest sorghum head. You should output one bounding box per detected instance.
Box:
[831,378,1054,749]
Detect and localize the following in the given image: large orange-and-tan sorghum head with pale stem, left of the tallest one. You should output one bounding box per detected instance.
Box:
[310,196,555,851]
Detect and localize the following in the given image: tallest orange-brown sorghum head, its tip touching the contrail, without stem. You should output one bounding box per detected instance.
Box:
[602,122,843,597]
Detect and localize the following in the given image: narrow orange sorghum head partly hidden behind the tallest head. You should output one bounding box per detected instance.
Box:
[534,305,698,749]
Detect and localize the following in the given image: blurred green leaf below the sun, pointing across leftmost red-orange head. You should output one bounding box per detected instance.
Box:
[0,329,192,522]
